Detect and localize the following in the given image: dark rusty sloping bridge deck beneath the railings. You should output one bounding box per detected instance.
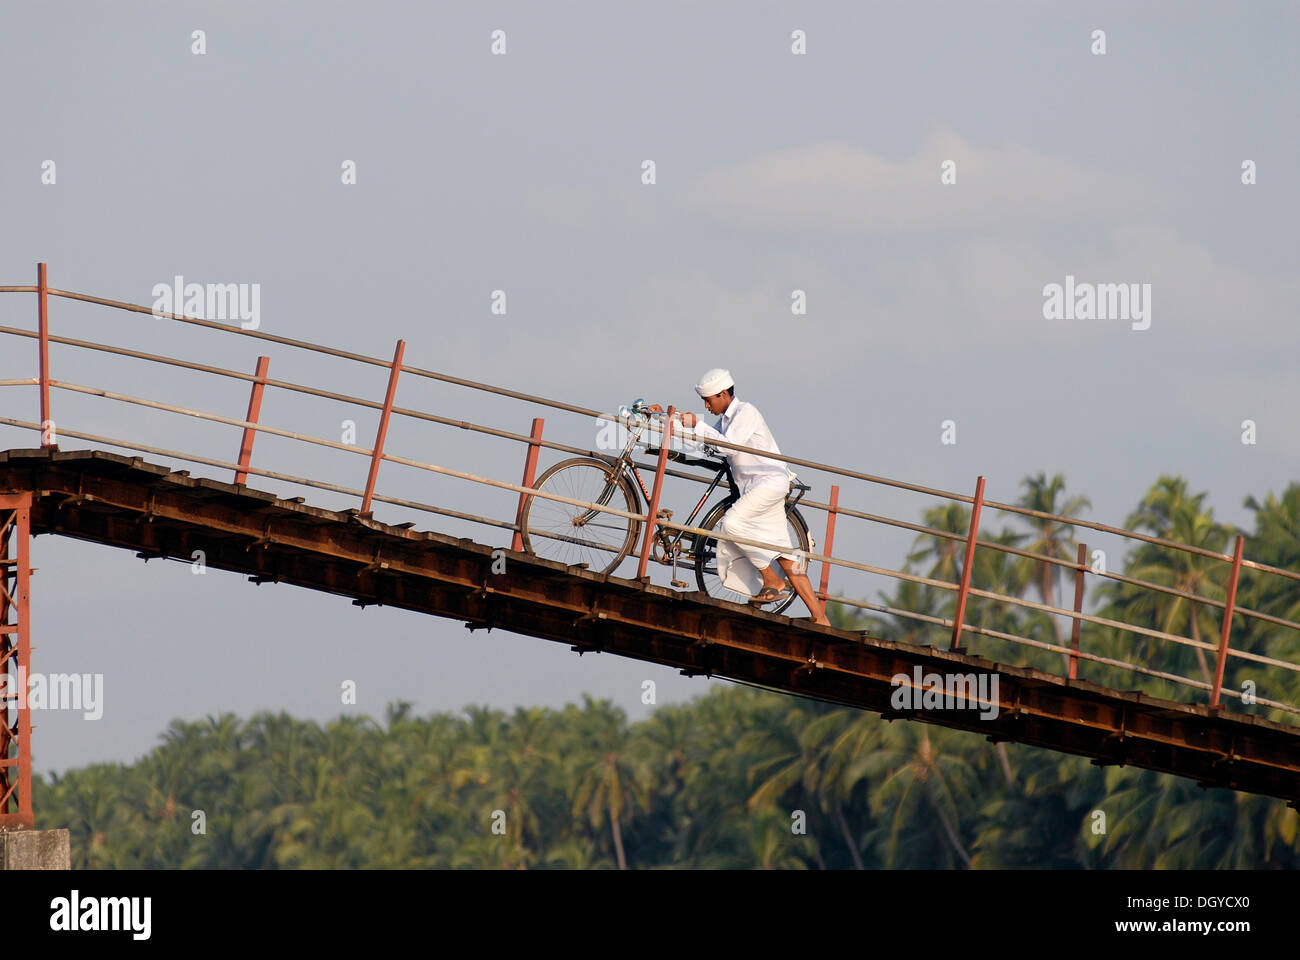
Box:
[0,450,1300,804]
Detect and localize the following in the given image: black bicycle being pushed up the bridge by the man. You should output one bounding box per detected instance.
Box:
[520,399,816,613]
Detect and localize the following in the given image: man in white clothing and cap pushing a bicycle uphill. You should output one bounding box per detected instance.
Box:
[650,369,831,626]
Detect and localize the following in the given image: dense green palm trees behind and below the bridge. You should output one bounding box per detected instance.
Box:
[35,475,1300,869]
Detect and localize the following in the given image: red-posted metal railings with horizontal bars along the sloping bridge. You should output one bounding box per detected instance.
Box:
[0,264,1300,714]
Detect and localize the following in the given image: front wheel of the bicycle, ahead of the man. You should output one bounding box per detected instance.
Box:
[520,457,641,574]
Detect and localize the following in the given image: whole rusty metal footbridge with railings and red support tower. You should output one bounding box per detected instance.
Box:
[0,264,1300,827]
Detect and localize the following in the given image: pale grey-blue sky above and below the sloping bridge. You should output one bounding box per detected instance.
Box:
[0,0,1300,771]
